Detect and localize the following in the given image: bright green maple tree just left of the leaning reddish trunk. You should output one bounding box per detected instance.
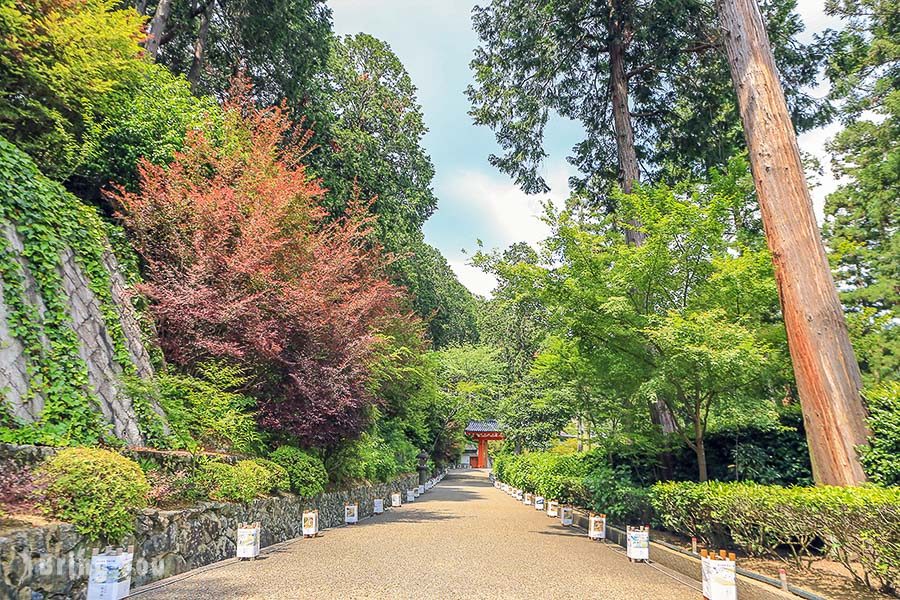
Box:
[478,165,790,479]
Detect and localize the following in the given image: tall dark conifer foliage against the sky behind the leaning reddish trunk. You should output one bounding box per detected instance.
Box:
[467,0,823,204]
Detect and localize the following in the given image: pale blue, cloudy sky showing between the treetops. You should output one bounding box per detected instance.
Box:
[329,0,840,296]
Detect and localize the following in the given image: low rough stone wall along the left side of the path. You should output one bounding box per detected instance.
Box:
[0,475,418,600]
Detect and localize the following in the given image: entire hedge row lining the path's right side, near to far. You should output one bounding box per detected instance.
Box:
[493,452,900,593]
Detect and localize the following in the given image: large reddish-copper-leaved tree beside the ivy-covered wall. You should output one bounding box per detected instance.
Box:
[114,79,409,446]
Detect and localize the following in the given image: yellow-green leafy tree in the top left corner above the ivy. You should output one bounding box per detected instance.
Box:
[0,0,148,181]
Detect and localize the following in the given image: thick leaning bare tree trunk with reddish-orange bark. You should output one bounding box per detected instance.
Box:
[716,0,867,485]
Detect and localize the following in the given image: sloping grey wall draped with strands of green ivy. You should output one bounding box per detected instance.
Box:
[0,138,166,445]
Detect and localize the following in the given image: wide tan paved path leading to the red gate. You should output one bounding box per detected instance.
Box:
[132,470,700,600]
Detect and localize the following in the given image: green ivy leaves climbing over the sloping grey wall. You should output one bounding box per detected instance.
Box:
[0,138,152,445]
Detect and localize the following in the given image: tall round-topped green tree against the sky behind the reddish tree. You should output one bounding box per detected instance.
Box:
[324,33,437,241]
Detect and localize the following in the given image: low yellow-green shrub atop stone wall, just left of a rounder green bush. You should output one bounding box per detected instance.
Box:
[195,460,276,503]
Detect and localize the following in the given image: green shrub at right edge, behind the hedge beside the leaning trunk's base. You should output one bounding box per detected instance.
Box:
[861,381,900,485]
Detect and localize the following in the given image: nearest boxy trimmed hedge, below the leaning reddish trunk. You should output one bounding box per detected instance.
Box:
[649,482,900,593]
